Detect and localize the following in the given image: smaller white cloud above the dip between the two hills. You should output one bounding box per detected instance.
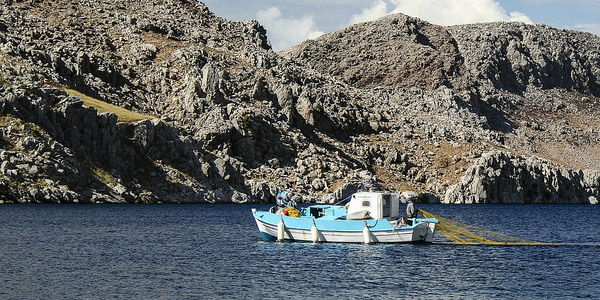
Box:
[256,7,324,51]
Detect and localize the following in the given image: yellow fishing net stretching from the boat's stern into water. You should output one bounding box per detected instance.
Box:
[419,210,550,246]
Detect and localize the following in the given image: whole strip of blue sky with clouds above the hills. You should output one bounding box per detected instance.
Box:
[201,0,600,51]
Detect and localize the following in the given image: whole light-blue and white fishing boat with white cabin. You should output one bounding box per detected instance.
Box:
[252,192,438,244]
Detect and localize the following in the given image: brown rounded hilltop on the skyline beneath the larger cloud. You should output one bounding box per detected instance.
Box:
[282,14,465,89]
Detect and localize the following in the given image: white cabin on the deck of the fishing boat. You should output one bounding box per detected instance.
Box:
[348,192,400,220]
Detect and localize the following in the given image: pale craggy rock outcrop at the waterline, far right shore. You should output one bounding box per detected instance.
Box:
[443,150,600,204]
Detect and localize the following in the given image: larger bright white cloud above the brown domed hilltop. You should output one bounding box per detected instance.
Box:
[391,0,533,25]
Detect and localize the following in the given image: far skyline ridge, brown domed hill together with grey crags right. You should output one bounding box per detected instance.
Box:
[281,14,600,96]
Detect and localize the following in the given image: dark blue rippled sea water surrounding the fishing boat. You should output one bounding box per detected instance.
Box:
[0,205,600,299]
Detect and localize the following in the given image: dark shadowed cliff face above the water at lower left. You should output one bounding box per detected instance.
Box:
[2,87,249,203]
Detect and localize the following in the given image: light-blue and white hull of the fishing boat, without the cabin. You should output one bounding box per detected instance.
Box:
[253,211,435,243]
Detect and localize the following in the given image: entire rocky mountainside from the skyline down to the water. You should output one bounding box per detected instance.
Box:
[0,0,600,203]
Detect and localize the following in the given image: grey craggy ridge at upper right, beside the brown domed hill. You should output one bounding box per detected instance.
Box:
[448,22,600,97]
